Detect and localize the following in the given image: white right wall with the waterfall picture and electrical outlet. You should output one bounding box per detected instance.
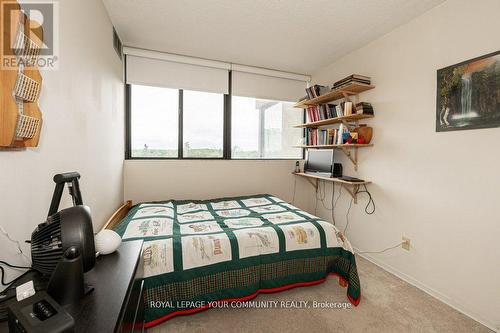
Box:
[310,0,500,329]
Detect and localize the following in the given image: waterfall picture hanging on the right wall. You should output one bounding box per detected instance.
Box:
[436,51,500,132]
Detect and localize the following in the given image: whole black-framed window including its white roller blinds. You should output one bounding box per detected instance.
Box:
[125,53,310,160]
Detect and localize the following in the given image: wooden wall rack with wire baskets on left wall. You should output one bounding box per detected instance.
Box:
[0,0,43,149]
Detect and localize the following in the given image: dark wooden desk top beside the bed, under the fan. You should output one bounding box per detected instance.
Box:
[0,241,144,333]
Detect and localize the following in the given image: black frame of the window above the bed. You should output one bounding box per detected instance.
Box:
[125,71,306,161]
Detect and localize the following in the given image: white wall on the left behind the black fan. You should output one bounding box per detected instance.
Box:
[0,0,124,286]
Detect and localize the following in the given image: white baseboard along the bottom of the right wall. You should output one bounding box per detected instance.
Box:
[354,248,500,333]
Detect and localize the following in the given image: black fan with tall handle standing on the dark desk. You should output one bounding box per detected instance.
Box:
[31,172,95,305]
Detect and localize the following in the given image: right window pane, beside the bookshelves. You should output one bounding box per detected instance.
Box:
[231,96,304,159]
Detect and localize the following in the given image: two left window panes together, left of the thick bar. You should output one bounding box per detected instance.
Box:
[128,84,224,158]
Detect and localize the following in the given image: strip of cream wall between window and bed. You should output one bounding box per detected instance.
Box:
[124,160,310,207]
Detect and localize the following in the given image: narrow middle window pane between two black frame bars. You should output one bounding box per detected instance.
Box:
[182,90,224,158]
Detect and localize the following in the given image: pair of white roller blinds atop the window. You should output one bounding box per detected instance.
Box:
[124,47,310,101]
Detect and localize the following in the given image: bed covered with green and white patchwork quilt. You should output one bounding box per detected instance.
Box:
[105,194,361,327]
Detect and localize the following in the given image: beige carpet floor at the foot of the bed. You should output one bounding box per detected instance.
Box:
[148,257,492,333]
